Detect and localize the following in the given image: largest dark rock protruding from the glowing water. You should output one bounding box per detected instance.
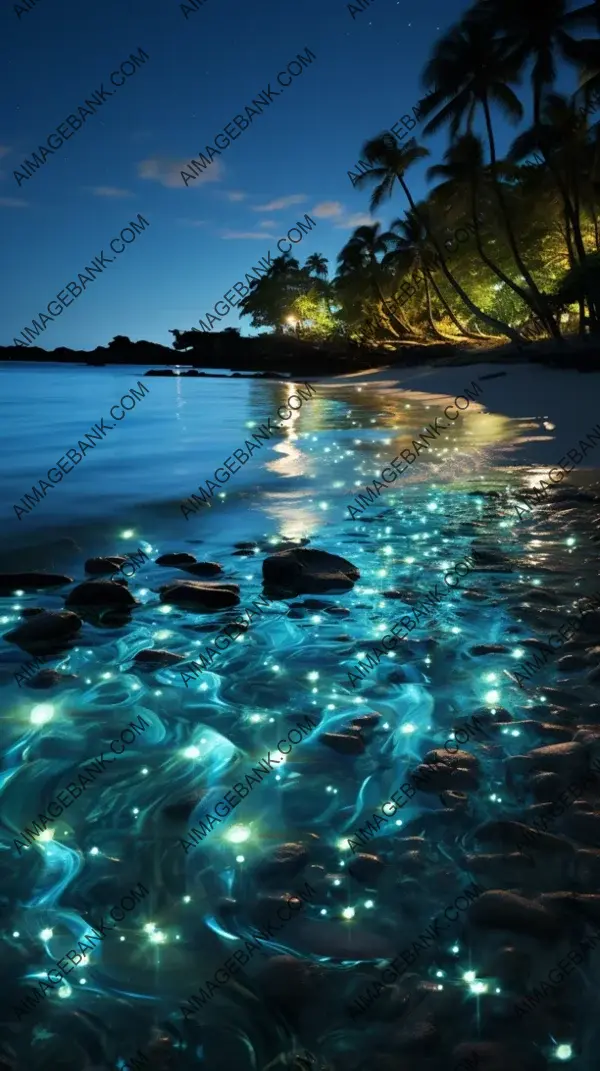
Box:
[263,547,360,595]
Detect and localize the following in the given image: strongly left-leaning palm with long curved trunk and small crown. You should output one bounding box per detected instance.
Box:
[355,128,521,343]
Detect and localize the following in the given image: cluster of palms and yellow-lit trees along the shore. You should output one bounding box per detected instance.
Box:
[174,0,600,346]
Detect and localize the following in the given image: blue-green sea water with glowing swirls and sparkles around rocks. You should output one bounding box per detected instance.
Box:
[0,367,600,1071]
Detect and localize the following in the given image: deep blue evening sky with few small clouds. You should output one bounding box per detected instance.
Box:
[0,0,578,349]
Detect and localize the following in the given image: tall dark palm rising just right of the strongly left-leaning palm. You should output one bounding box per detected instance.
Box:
[421,15,560,338]
